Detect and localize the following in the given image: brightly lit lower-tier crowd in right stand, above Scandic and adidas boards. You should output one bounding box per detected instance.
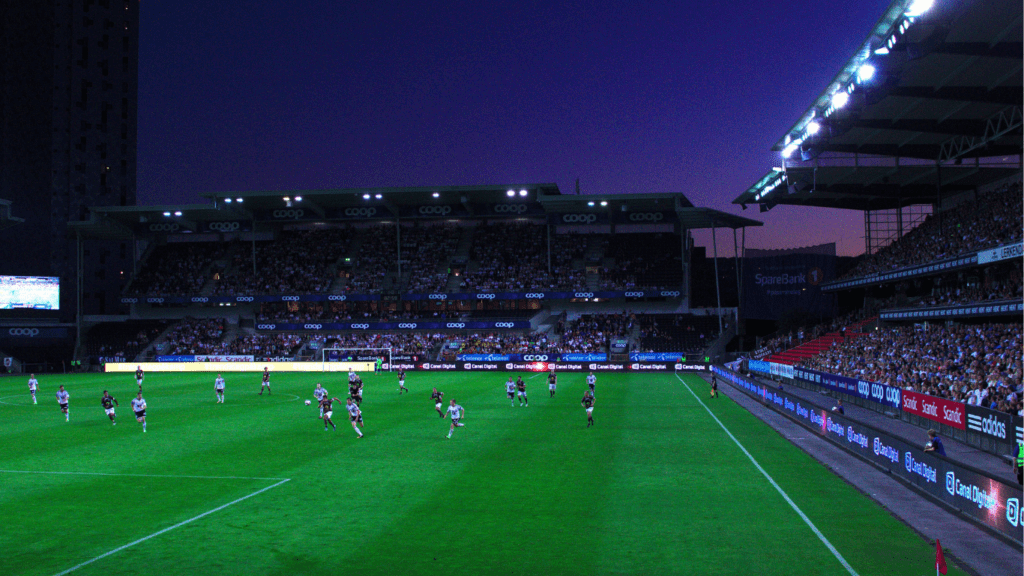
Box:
[803,323,1024,415]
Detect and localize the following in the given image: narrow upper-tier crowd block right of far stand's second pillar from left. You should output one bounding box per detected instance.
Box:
[401,223,462,293]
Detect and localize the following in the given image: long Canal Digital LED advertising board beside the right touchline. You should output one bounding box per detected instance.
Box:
[713,367,1024,542]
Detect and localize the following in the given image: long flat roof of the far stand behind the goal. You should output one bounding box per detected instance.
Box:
[69,183,762,233]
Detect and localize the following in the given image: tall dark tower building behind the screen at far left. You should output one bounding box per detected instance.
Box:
[0,0,139,321]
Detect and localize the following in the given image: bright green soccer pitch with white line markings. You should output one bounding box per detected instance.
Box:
[0,372,964,576]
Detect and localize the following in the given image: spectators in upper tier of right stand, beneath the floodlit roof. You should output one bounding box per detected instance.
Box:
[845,182,1024,278]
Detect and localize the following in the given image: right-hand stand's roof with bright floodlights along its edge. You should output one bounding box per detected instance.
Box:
[734,0,1024,209]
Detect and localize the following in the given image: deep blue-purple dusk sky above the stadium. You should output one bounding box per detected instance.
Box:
[138,0,889,255]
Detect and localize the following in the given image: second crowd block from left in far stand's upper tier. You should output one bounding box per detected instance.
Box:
[214,229,351,295]
